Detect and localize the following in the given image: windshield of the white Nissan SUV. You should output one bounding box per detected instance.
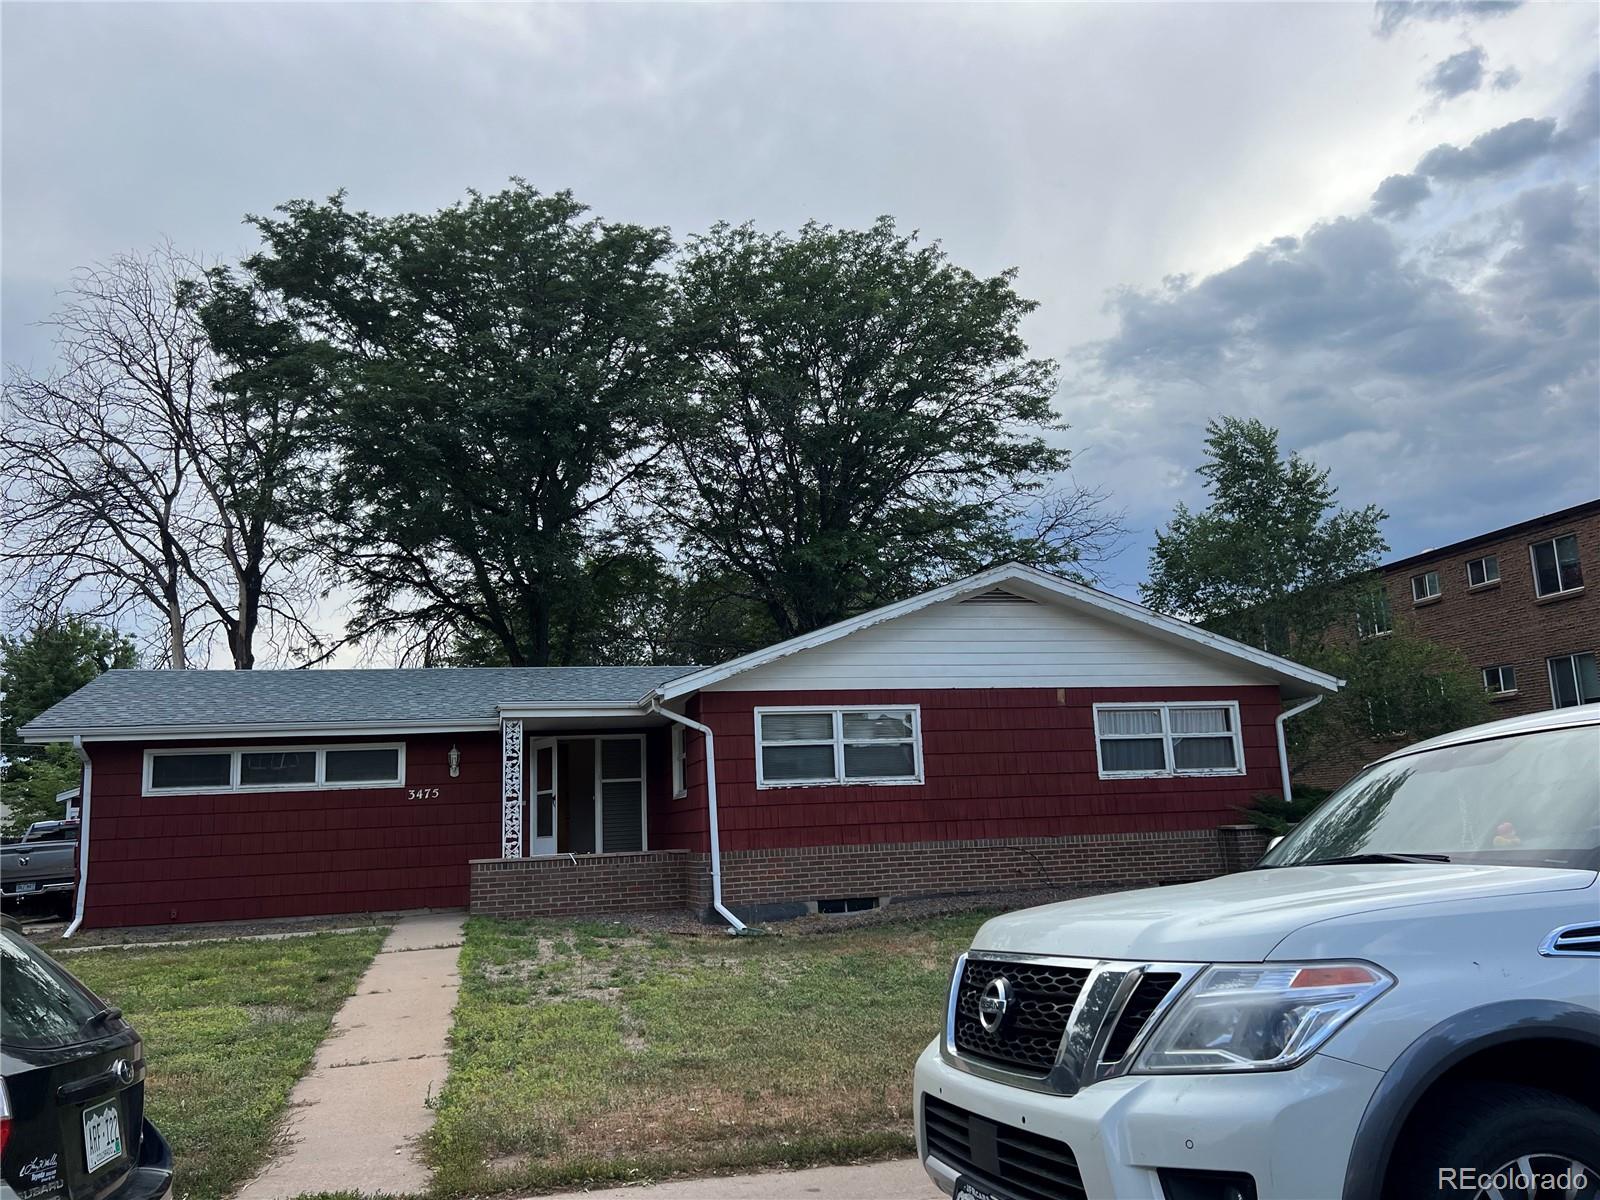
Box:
[1261,725,1600,870]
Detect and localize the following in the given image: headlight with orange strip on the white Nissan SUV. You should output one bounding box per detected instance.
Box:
[1133,963,1395,1074]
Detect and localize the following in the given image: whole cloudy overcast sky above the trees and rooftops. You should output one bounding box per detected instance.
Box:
[0,2,1600,630]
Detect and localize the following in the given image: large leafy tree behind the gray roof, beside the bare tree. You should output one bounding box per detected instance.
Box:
[206,182,675,666]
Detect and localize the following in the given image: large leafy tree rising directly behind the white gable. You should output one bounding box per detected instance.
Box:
[661,218,1117,637]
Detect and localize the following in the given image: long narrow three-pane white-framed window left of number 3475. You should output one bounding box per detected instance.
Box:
[142,742,405,795]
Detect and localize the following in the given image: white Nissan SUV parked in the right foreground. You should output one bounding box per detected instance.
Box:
[915,706,1600,1200]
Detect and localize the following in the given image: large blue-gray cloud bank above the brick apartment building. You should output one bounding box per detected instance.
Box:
[1064,150,1600,582]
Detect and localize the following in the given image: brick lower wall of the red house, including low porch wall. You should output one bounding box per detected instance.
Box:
[472,826,1266,918]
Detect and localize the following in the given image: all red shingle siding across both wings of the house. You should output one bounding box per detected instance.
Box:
[85,686,1278,926]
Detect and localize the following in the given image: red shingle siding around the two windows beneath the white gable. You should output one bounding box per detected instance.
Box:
[653,686,1280,851]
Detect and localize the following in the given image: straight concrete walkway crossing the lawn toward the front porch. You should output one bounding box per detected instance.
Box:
[238,912,466,1200]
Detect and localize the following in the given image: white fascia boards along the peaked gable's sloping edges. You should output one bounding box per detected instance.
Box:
[645,563,1344,702]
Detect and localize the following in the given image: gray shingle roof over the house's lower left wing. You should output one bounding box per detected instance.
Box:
[22,667,699,736]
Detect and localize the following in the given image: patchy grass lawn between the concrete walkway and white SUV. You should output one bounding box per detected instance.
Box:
[427,914,987,1197]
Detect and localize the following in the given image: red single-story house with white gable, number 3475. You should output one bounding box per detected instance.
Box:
[22,565,1339,926]
